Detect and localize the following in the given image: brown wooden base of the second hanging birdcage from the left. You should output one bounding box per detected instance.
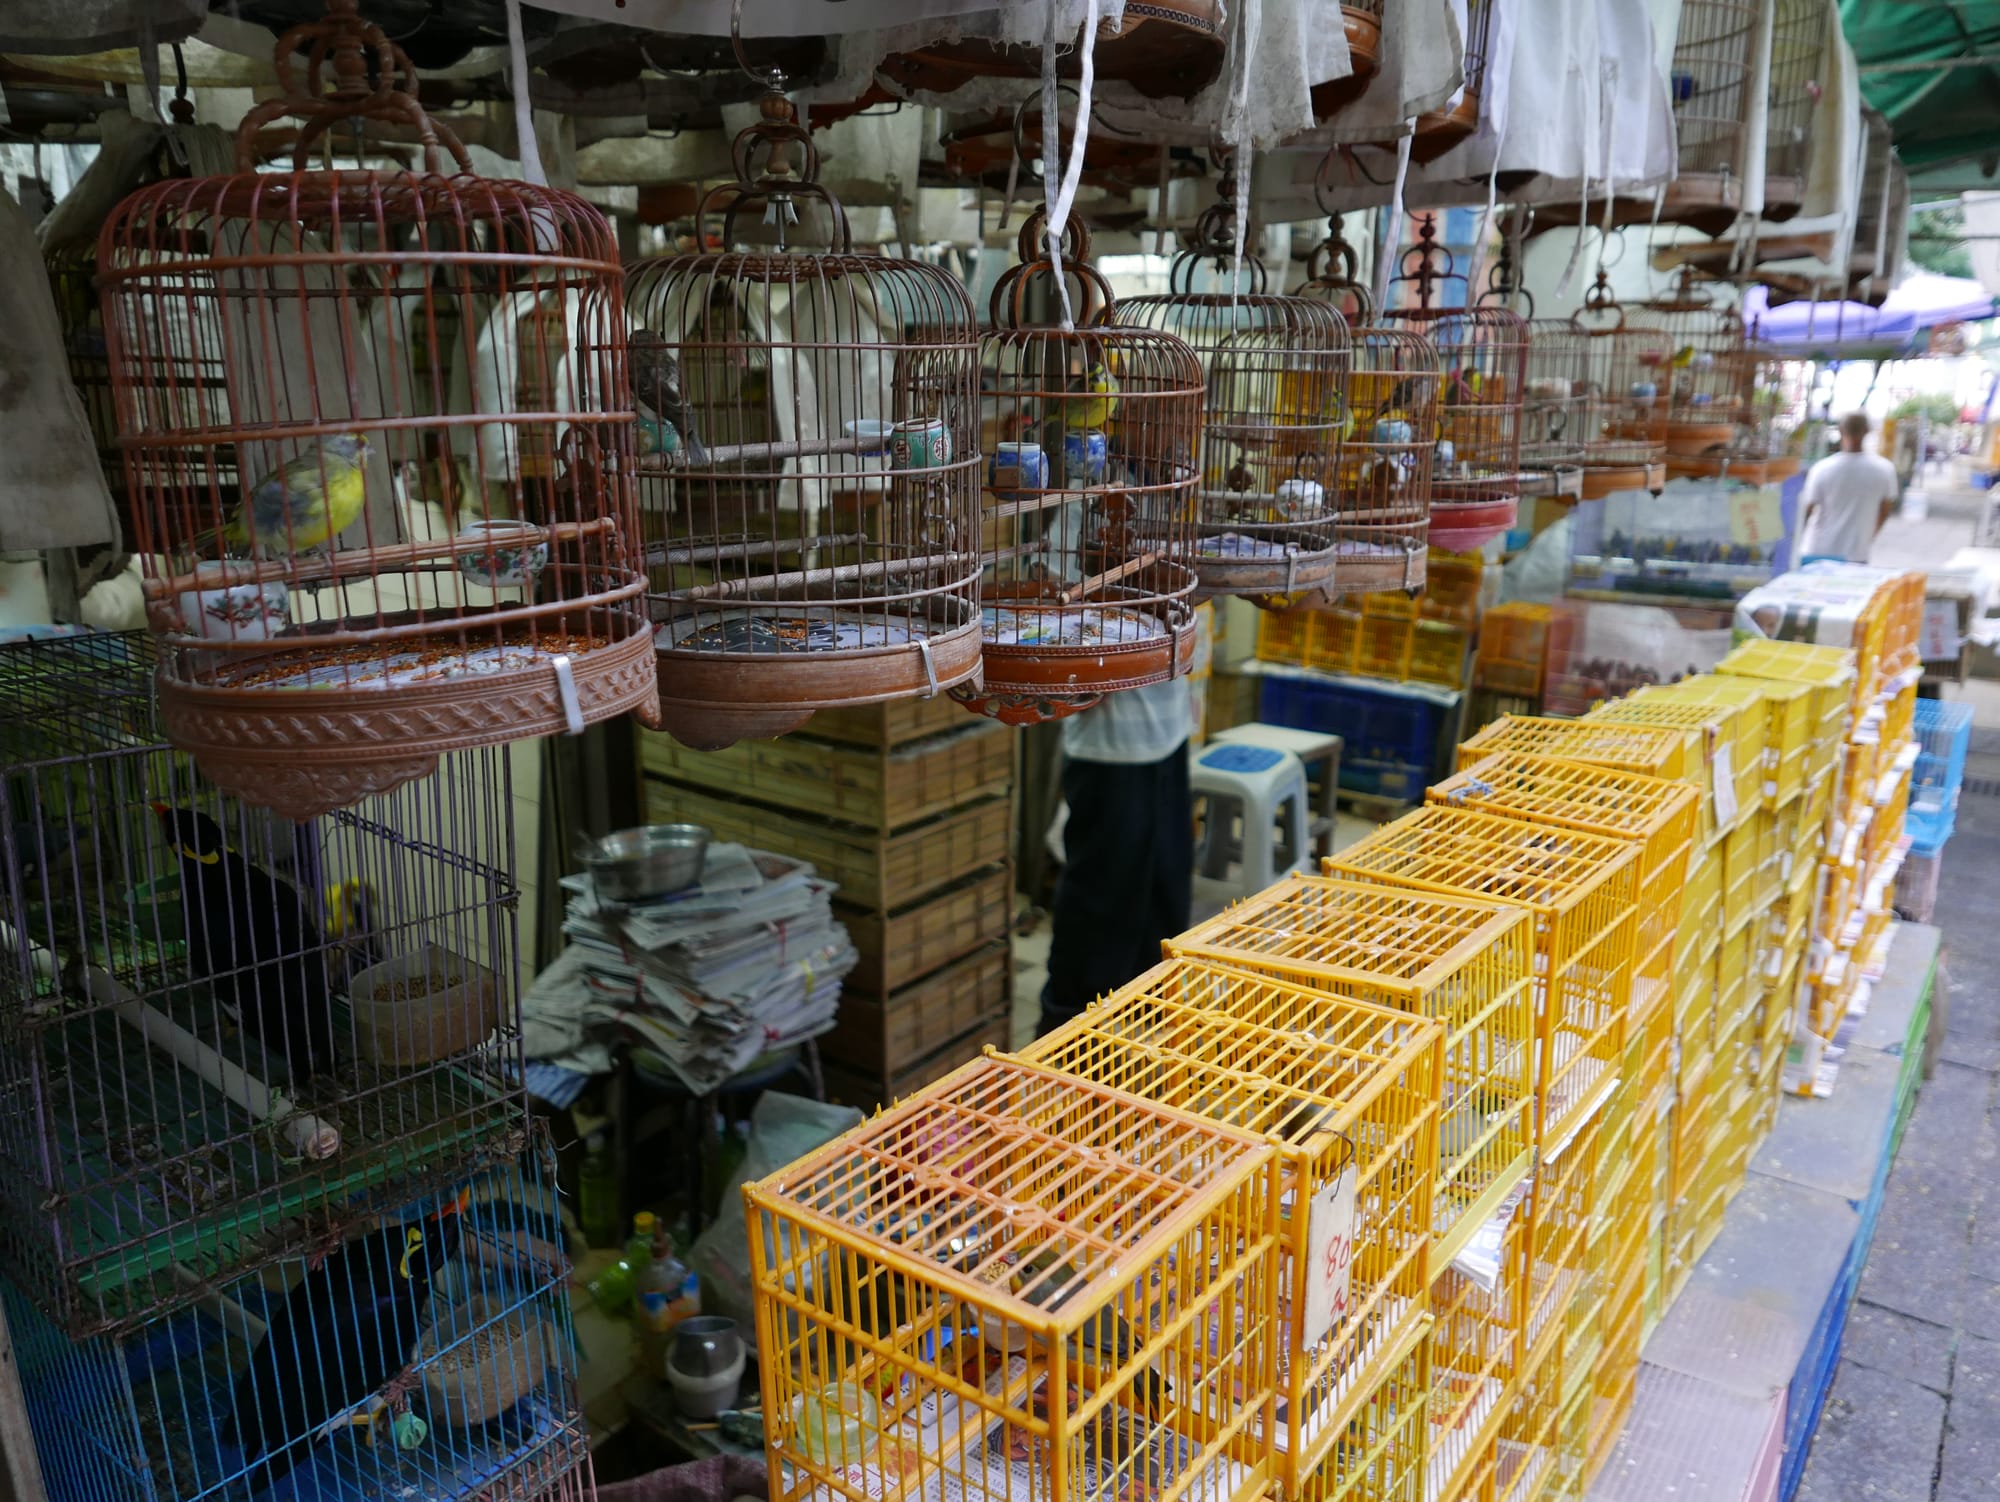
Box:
[656,600,980,750]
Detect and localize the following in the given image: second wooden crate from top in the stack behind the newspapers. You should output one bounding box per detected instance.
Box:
[640,716,1014,830]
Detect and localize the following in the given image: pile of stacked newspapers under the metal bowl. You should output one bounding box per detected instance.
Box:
[522,844,858,1092]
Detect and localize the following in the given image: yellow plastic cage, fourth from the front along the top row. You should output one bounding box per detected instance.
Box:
[1326,804,1638,1144]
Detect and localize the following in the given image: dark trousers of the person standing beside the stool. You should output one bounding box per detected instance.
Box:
[1040,744,1194,1032]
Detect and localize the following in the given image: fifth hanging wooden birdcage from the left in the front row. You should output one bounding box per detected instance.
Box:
[1298,207,1442,604]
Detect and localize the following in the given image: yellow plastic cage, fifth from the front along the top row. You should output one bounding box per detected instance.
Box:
[1430,752,1700,1018]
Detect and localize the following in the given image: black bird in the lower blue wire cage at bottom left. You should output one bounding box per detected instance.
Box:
[222,1194,470,1490]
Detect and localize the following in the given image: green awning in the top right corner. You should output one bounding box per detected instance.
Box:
[1840,0,2000,192]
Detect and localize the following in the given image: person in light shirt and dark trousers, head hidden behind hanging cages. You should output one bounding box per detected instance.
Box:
[1040,676,1194,1032]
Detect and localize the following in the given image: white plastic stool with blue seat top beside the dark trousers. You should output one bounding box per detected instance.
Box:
[1188,742,1312,922]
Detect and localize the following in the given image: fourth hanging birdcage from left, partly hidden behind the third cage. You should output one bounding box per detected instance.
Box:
[1112,160,1348,604]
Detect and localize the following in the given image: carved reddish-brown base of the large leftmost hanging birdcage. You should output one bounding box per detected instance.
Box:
[158,634,660,820]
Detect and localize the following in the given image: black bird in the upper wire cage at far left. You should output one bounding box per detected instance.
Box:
[152,804,334,1082]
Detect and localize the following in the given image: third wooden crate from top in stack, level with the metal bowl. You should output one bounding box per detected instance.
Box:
[646,778,1014,908]
